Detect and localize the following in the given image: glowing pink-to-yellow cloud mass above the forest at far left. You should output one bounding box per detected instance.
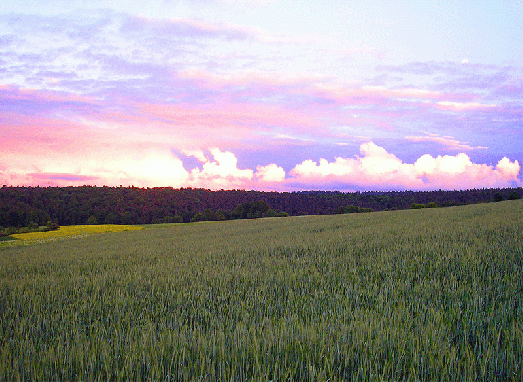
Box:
[0,102,193,186]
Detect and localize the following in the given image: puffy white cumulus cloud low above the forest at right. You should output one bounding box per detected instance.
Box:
[291,142,521,189]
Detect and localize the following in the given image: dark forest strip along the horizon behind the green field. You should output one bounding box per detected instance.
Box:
[0,185,523,230]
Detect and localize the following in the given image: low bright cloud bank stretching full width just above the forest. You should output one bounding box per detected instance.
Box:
[0,142,522,190]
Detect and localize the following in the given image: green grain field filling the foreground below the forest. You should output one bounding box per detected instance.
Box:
[0,200,523,381]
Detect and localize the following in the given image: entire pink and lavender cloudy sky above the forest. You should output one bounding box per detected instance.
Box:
[0,0,523,191]
